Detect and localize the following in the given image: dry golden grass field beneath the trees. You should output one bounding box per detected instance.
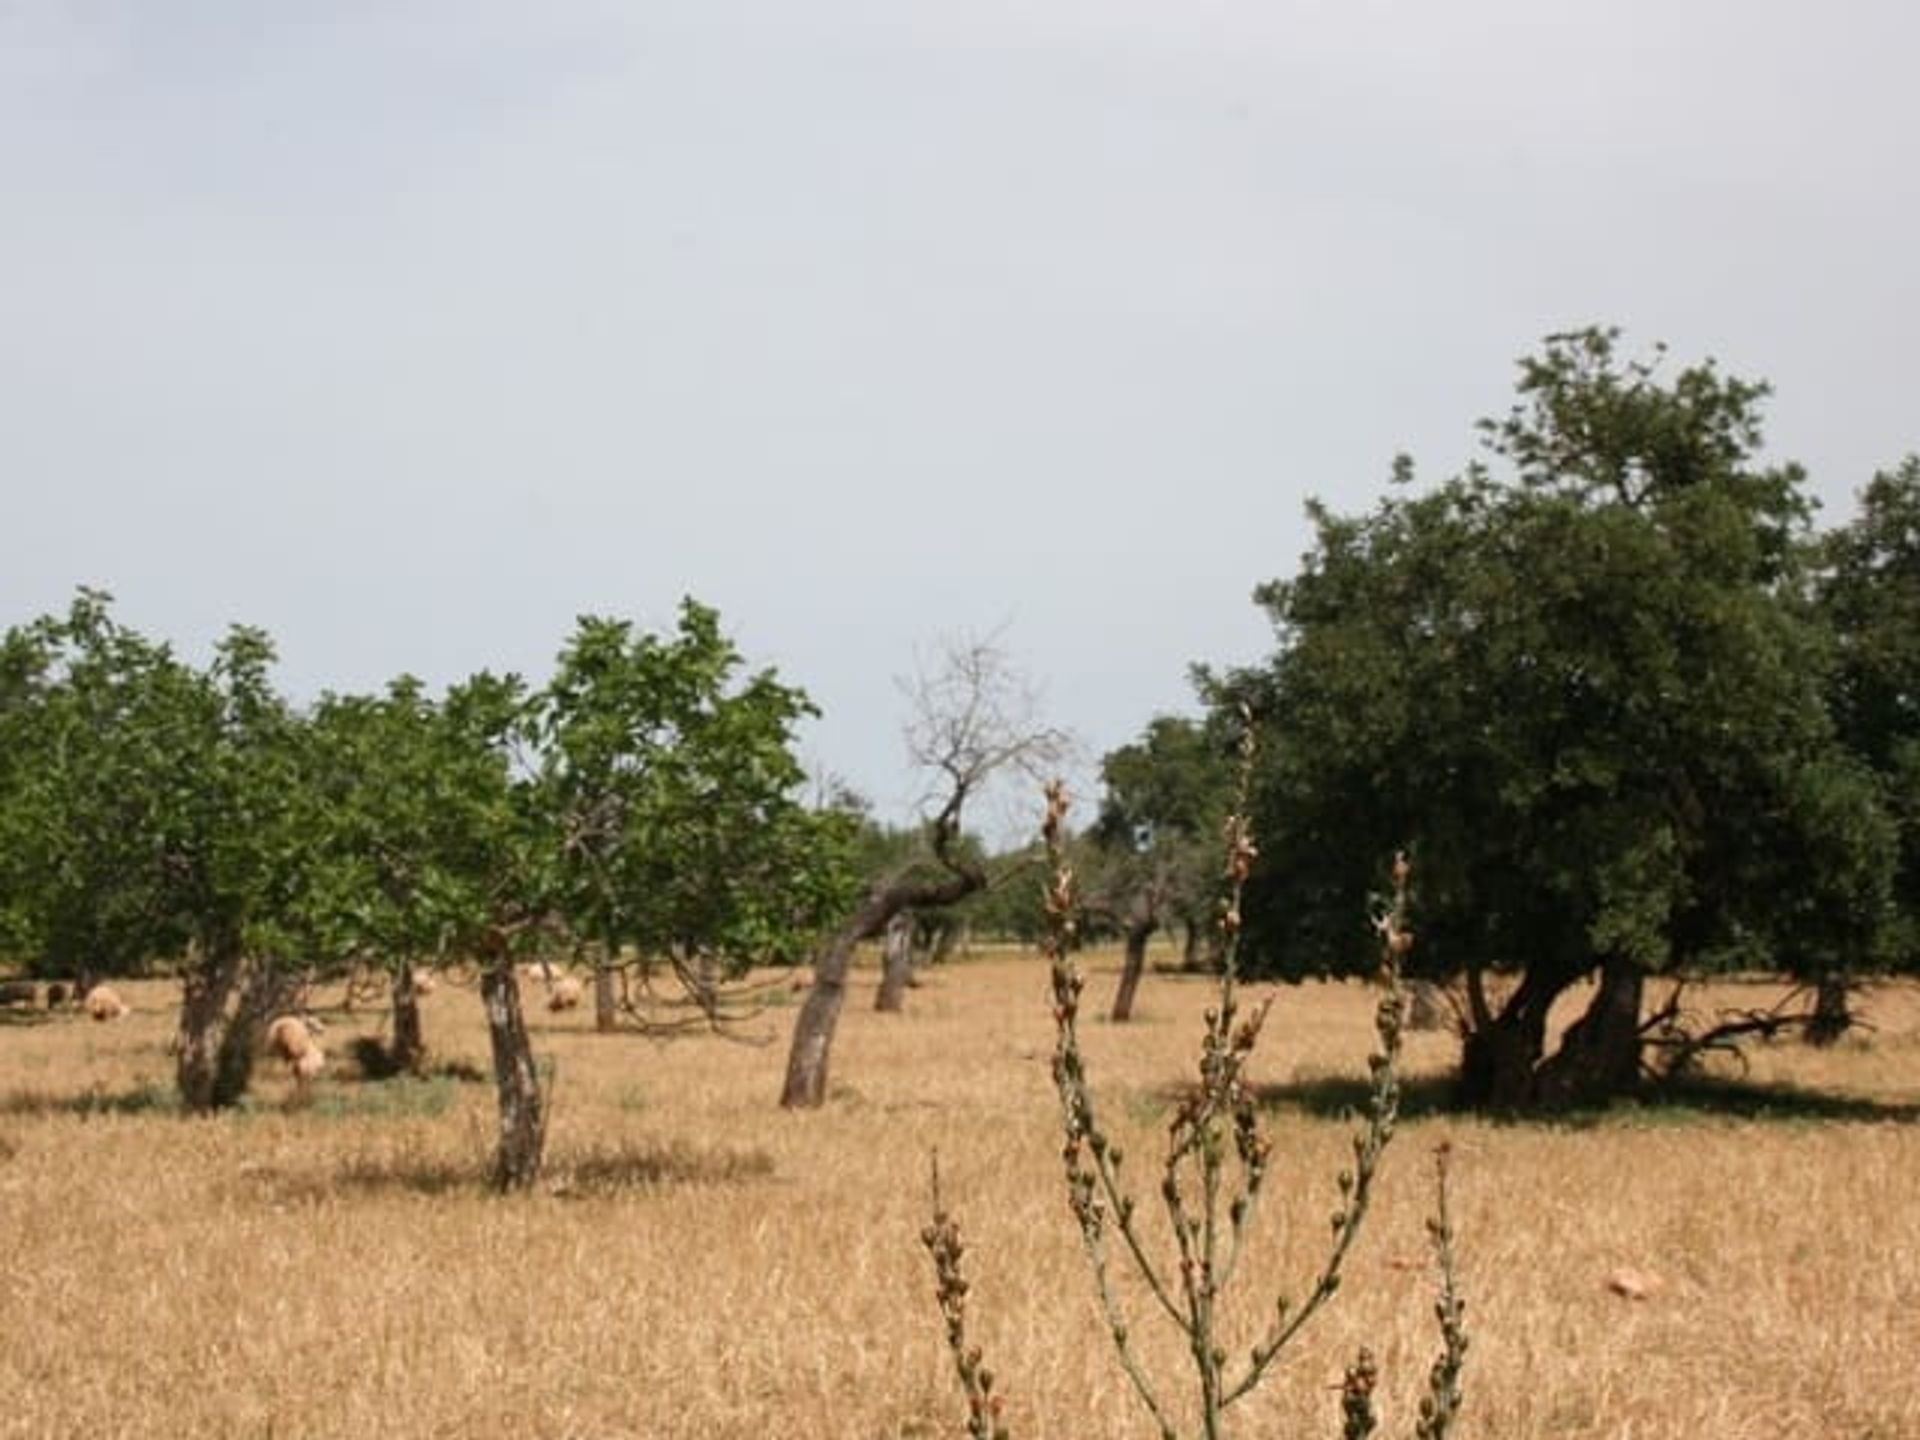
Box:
[0,956,1920,1440]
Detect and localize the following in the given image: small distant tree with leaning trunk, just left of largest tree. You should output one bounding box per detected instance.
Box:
[1083,716,1233,1023]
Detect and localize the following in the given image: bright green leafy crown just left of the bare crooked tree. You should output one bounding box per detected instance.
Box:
[530,599,851,1029]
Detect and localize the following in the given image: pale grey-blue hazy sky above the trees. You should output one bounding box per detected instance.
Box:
[0,0,1920,833]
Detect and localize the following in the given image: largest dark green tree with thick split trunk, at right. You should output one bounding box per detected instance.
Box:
[1221,330,1891,1106]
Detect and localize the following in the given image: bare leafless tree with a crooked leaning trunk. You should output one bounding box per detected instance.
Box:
[780,641,1064,1108]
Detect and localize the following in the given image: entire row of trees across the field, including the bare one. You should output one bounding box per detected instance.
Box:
[0,330,1920,1128]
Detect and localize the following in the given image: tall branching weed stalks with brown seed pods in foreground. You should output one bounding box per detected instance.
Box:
[922,726,1467,1440]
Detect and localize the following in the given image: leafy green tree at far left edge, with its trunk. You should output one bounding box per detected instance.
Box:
[0,589,303,1112]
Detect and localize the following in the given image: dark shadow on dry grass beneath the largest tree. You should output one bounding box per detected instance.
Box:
[1256,1075,1920,1129]
